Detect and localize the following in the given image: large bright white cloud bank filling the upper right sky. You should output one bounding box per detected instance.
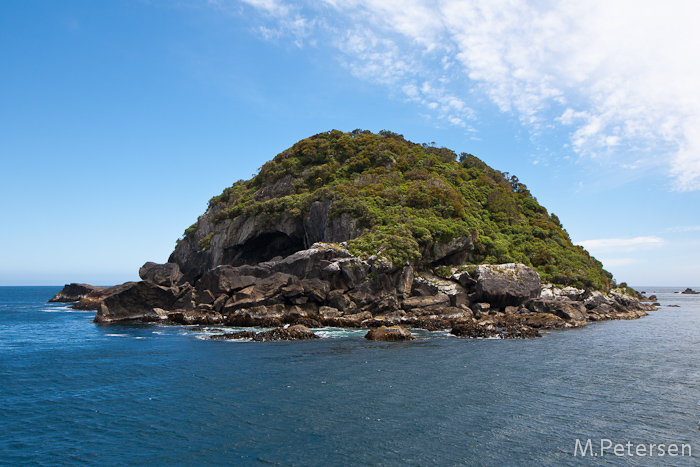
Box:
[226,0,700,191]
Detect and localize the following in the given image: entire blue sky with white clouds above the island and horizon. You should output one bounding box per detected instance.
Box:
[0,0,700,287]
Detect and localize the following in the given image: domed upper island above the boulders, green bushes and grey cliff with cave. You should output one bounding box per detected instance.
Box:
[169,131,611,290]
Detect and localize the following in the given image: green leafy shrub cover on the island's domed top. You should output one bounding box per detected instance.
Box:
[184,130,612,291]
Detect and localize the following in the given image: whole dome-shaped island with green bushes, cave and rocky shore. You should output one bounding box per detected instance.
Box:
[52,130,654,340]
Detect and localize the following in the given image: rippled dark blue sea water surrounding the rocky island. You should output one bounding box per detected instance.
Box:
[0,287,700,467]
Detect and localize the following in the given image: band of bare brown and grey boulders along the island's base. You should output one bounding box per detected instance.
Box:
[51,243,655,341]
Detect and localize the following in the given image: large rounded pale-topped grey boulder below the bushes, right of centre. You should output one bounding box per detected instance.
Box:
[475,263,542,308]
